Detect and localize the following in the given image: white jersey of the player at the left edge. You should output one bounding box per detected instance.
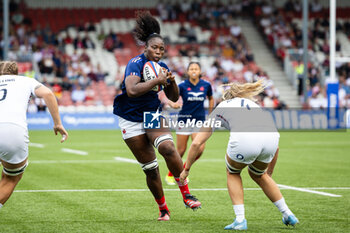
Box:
[0,75,42,128]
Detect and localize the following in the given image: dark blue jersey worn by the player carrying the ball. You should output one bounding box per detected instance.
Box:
[113,54,169,122]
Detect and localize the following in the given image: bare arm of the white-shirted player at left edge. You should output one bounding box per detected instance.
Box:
[35,85,68,142]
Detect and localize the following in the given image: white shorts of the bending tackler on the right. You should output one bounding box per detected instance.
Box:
[226,132,280,164]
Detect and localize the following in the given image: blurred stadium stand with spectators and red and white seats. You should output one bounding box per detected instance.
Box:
[1,0,350,129]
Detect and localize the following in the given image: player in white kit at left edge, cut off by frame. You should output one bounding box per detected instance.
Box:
[0,61,68,209]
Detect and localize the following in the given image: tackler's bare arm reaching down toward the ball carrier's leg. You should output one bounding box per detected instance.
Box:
[180,127,213,183]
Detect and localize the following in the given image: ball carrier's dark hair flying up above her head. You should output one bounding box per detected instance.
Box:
[134,11,163,45]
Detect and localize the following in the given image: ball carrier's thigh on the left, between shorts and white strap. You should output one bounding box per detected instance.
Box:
[124,134,156,164]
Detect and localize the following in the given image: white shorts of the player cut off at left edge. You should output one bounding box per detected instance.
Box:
[0,123,29,164]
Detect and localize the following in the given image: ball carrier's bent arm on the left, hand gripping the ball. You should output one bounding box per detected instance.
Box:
[125,71,167,98]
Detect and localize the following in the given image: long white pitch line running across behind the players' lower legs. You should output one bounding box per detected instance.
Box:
[15,185,350,194]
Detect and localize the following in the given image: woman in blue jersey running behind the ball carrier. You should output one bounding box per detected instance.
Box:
[165,62,214,185]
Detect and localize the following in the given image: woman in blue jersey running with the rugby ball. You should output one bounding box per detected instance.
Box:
[113,12,201,221]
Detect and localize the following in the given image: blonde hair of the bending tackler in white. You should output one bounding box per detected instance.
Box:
[222,79,265,101]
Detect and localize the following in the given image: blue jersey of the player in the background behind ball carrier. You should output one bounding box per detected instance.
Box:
[178,79,213,121]
